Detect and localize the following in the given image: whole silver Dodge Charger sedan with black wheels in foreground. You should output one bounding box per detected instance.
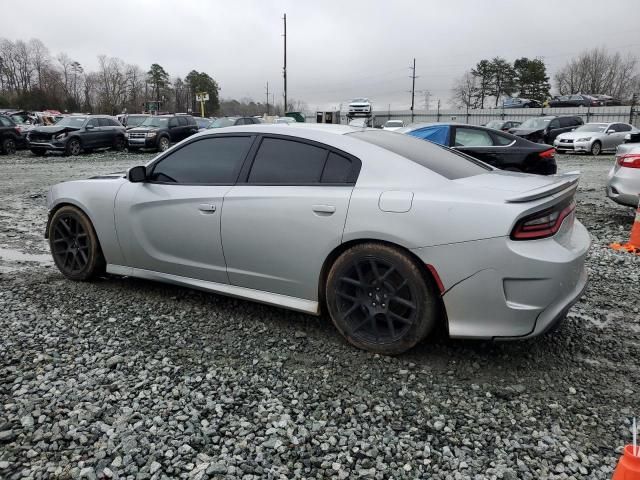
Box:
[47,125,590,354]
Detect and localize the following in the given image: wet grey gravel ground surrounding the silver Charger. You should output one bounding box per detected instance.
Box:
[0,148,640,479]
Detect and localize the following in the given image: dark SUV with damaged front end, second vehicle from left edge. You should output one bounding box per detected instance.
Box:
[27,115,125,155]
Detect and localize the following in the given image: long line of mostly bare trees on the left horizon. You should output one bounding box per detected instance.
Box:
[0,39,220,115]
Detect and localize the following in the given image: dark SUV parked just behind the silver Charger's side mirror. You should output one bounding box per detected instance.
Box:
[126,115,198,152]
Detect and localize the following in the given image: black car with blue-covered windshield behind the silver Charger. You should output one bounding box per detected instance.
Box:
[397,123,557,175]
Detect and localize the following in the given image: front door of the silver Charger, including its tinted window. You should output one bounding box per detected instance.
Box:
[115,135,253,283]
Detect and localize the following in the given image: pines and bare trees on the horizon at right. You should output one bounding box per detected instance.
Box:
[451,48,640,108]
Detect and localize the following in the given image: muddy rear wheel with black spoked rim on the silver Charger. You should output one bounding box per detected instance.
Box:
[325,243,438,355]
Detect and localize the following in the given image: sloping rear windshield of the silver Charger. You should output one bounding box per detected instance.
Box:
[348,130,492,180]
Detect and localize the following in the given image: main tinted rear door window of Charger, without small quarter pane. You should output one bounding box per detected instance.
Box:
[249,138,327,185]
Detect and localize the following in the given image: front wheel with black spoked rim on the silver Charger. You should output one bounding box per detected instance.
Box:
[48,206,105,281]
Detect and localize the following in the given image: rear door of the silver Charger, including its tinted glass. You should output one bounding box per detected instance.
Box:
[222,135,360,300]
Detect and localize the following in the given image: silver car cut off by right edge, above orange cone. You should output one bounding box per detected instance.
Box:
[607,139,640,208]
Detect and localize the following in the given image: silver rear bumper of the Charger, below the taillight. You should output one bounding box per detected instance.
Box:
[413,217,591,339]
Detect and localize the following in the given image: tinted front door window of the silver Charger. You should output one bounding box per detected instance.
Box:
[151,137,252,185]
